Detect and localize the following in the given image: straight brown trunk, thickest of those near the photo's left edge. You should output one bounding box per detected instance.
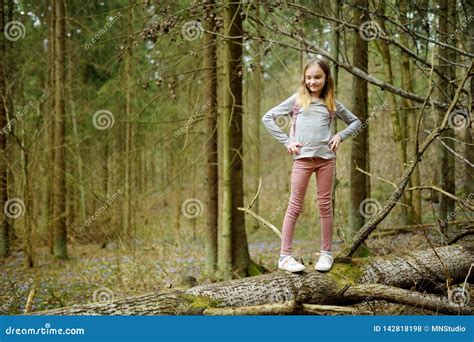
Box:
[52,0,68,259]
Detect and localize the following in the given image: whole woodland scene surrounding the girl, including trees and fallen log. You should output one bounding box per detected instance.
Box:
[0,0,474,315]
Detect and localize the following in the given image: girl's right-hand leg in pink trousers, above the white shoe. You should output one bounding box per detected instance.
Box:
[316,158,336,251]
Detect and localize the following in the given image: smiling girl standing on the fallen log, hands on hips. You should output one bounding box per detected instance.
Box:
[262,58,361,272]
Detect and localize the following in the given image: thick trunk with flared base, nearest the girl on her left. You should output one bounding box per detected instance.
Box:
[221,2,252,279]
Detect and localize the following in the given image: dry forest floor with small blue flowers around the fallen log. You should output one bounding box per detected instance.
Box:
[0,224,466,315]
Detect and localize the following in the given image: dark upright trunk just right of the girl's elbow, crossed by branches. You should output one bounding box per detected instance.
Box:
[349,0,370,238]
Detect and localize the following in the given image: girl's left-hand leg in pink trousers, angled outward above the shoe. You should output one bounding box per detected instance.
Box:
[280,158,314,255]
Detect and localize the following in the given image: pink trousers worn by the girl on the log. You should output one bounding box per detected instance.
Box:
[281,157,336,255]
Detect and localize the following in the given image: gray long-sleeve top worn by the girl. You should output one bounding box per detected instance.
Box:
[262,94,362,160]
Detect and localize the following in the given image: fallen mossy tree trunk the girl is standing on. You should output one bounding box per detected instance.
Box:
[35,243,474,315]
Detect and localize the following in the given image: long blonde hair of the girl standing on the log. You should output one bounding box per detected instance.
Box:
[296,58,336,119]
